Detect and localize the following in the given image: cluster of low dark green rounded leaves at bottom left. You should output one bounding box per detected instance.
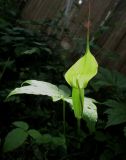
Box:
[3,121,66,152]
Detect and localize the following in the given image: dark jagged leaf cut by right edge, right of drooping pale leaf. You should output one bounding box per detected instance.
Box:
[103,100,126,127]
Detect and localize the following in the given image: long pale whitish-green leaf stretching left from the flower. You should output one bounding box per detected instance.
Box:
[7,80,68,101]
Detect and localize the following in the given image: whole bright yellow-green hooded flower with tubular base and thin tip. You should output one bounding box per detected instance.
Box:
[65,34,98,119]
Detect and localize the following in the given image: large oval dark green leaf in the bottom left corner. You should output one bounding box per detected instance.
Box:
[3,128,28,152]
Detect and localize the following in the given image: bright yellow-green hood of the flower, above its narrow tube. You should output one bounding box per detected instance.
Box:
[65,48,98,88]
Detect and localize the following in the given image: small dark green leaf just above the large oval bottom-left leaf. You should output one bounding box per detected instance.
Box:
[12,121,29,131]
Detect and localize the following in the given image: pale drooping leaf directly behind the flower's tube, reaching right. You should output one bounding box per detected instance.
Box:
[64,97,98,132]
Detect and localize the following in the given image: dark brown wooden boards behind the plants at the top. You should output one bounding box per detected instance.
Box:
[22,0,126,73]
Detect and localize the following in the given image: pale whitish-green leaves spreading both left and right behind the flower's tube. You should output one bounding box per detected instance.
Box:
[7,80,97,134]
